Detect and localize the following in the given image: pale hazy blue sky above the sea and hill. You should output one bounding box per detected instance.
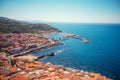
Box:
[0,0,120,23]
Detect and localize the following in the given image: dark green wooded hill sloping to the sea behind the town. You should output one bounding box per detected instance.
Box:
[0,17,61,33]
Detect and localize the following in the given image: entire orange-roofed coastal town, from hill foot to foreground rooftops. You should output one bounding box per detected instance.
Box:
[0,33,111,80]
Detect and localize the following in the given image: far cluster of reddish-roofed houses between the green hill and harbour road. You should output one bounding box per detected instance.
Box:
[0,33,50,54]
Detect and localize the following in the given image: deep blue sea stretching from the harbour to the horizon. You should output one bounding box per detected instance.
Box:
[33,23,120,80]
